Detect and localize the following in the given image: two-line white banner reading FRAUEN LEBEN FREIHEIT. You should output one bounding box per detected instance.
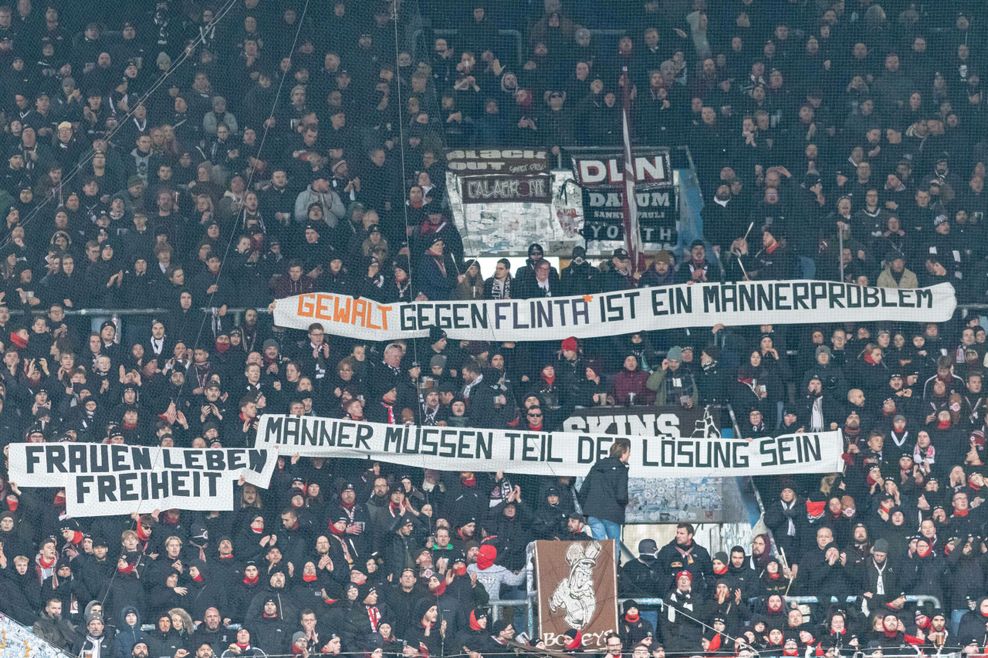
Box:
[8,443,278,518]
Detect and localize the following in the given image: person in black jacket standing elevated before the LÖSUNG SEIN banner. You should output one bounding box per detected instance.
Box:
[579,439,631,539]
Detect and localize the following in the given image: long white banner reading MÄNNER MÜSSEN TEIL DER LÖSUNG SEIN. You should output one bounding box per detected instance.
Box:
[254,414,844,478]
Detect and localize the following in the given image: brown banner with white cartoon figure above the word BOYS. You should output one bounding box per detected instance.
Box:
[535,539,619,651]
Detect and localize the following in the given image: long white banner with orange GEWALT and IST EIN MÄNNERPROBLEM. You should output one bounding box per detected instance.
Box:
[274,281,957,341]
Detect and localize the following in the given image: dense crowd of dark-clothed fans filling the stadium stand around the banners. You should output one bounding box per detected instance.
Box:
[0,0,988,658]
